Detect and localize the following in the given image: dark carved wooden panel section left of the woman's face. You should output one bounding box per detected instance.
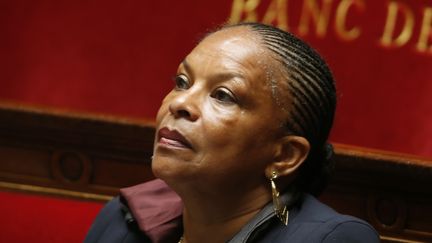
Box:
[0,104,154,195]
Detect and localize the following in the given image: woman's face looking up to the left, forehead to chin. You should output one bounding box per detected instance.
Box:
[152,27,290,190]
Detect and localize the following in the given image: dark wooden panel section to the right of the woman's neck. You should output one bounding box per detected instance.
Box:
[320,145,432,242]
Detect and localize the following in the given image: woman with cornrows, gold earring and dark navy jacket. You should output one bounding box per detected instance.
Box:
[86,23,379,243]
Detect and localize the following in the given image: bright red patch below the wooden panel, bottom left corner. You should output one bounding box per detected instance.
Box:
[0,191,103,243]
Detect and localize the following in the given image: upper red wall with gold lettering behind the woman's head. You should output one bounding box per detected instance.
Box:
[0,0,432,157]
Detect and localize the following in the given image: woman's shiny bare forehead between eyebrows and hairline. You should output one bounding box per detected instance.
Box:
[180,27,269,85]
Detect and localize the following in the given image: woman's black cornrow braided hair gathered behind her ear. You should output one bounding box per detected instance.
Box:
[225,23,336,195]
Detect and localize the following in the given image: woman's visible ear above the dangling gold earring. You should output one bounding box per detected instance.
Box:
[265,135,310,178]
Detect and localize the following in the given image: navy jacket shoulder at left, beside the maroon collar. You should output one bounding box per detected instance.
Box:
[84,197,150,243]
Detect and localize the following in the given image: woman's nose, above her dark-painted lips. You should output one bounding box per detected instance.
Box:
[169,90,199,121]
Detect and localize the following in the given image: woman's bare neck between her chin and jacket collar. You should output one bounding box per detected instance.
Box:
[182,184,271,243]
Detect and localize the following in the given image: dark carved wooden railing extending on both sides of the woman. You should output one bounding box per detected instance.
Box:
[0,104,432,242]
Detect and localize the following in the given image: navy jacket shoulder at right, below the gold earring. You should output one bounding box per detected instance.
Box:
[274,195,379,243]
